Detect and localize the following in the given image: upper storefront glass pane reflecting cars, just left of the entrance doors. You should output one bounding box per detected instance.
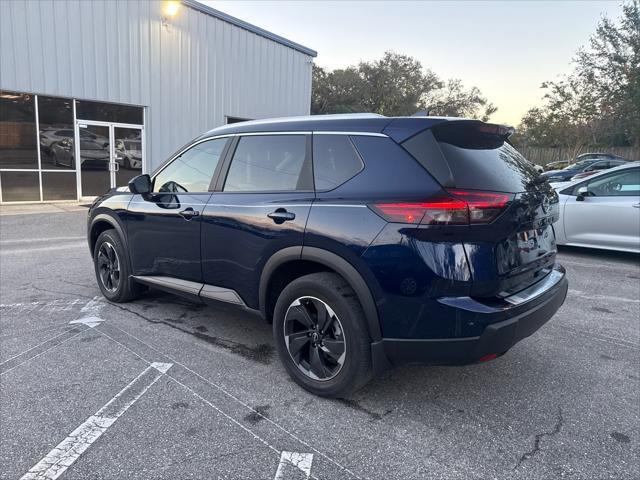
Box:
[38,96,75,170]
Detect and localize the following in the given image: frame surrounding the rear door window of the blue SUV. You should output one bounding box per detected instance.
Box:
[213,131,315,195]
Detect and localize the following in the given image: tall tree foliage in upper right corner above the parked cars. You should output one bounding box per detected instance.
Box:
[513,0,640,148]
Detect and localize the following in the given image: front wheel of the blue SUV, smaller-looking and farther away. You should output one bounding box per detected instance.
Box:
[93,230,145,303]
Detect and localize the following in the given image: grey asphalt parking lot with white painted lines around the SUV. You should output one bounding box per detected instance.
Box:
[0,208,640,479]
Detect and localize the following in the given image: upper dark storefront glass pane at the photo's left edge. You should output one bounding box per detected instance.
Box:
[0,90,38,170]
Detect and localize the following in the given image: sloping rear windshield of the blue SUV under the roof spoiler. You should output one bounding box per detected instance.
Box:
[403,122,538,193]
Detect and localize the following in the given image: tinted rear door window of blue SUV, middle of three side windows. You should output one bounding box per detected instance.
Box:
[223,135,311,192]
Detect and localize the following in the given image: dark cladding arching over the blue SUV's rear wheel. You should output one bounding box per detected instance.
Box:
[259,247,382,341]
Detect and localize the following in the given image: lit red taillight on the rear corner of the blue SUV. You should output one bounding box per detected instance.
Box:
[370,190,513,225]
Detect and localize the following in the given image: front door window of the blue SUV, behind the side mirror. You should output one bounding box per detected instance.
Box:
[153,138,227,193]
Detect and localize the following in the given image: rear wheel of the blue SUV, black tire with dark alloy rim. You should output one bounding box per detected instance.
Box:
[273,272,373,397]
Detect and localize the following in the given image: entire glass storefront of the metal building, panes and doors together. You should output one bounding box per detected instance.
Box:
[0,90,144,203]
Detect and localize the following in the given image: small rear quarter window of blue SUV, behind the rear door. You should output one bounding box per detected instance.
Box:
[313,134,364,191]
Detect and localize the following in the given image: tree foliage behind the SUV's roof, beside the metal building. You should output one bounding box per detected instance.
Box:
[311,52,496,120]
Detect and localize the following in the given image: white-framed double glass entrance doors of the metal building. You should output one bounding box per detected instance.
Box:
[76,120,144,197]
